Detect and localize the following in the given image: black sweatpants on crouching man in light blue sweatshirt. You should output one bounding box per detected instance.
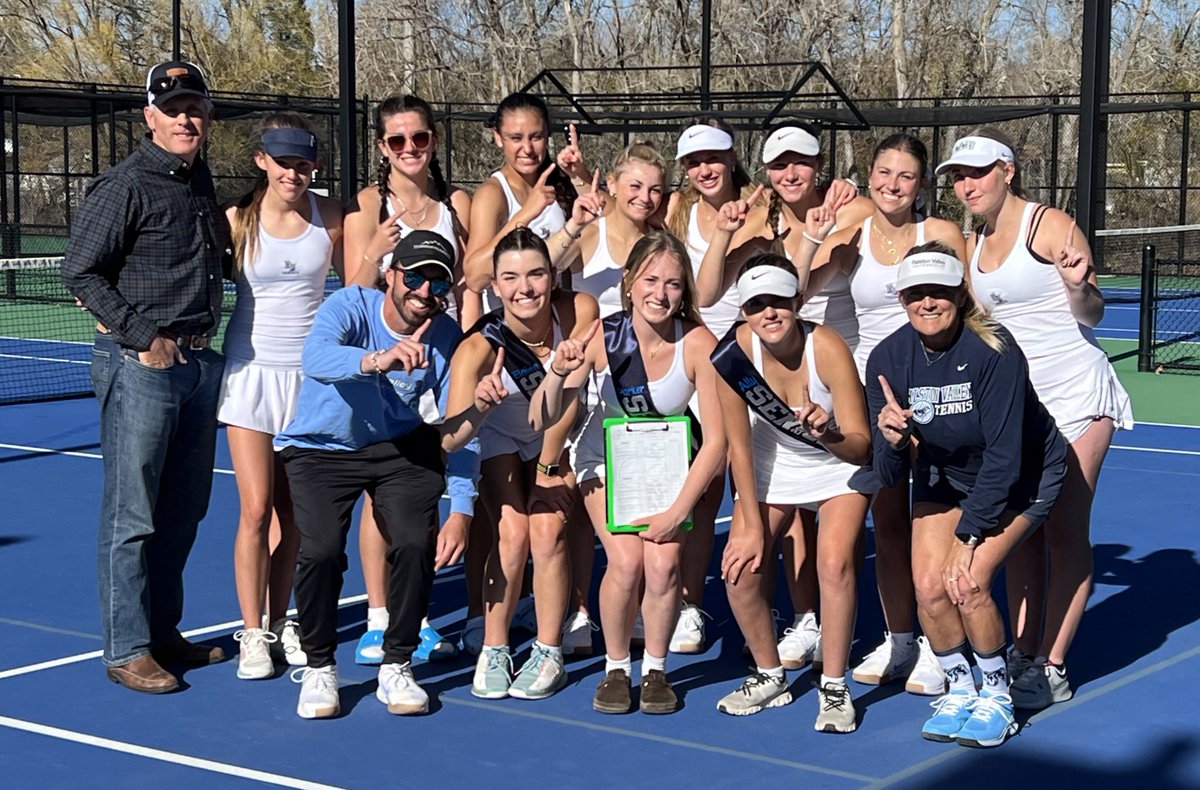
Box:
[282,425,445,668]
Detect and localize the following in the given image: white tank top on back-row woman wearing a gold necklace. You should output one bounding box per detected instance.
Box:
[850,212,925,381]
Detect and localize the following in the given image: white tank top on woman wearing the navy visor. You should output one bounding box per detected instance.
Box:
[222,192,334,370]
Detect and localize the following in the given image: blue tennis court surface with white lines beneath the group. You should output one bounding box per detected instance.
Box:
[0,386,1200,790]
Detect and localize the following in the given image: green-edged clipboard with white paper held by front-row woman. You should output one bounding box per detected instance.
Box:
[604,414,692,532]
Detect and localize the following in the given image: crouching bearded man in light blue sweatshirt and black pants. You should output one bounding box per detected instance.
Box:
[275,231,479,718]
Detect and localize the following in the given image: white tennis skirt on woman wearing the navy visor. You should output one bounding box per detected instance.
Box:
[217,359,304,436]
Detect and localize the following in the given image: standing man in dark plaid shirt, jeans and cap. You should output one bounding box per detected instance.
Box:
[62,61,229,694]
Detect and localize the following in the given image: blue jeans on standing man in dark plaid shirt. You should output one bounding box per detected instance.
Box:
[91,333,224,666]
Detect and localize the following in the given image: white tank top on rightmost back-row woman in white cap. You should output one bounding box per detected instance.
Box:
[971,203,1106,364]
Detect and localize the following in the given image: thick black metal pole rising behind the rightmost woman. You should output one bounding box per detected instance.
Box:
[1075,0,1112,249]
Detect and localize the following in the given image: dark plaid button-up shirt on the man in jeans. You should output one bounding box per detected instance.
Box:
[62,136,229,351]
